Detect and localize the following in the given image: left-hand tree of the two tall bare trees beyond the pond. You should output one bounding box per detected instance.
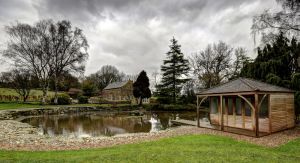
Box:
[4,20,53,103]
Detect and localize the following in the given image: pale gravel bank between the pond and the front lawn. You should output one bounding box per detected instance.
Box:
[0,120,300,151]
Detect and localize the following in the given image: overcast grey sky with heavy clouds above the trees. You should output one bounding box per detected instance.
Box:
[0,0,277,75]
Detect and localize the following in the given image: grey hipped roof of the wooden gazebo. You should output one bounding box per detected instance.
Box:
[198,78,294,95]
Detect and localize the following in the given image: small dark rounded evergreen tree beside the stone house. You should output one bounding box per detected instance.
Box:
[133,70,151,106]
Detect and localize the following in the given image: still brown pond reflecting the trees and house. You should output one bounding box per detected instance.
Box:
[21,111,196,137]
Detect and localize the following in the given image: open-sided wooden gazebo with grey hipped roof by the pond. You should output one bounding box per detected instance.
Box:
[197,78,295,137]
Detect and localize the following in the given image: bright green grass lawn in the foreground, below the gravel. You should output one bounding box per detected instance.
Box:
[0,135,300,163]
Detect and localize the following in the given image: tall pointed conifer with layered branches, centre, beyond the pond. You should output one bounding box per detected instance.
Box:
[159,37,190,103]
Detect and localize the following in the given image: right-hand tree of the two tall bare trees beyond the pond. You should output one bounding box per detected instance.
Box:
[48,20,88,103]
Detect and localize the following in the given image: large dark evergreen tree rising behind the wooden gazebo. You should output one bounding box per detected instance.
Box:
[241,33,300,87]
